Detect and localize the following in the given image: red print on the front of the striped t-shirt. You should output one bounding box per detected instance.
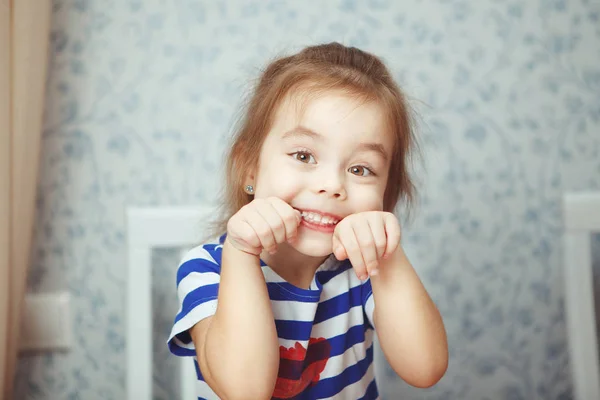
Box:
[273,338,331,399]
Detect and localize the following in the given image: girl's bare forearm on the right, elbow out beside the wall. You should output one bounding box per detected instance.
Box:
[371,246,448,387]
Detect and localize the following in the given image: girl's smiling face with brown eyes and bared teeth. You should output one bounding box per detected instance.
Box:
[249,92,394,257]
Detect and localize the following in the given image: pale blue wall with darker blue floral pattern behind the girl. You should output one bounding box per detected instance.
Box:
[17,0,600,400]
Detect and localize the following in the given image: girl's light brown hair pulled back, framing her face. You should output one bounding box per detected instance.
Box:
[211,42,416,239]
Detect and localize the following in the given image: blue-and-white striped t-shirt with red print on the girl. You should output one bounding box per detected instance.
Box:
[168,237,378,400]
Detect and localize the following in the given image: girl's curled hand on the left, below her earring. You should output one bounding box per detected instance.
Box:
[227,197,302,256]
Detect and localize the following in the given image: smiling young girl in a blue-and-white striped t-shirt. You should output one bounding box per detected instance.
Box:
[168,43,448,400]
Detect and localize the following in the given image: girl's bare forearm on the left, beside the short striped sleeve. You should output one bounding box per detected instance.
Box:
[199,240,279,399]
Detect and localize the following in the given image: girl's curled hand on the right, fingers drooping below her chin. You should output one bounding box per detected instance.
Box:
[332,211,400,280]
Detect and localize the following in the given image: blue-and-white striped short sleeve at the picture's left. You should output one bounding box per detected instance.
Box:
[167,245,222,356]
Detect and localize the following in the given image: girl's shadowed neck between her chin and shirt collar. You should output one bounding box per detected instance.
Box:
[260,243,327,289]
